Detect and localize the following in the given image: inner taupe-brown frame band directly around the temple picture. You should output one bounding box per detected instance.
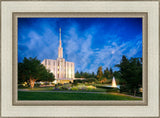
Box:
[12,12,148,106]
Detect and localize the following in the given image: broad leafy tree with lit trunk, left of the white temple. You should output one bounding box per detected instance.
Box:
[18,57,55,88]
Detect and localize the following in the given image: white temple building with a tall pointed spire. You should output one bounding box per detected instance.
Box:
[42,28,74,84]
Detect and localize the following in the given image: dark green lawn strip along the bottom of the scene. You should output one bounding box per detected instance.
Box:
[18,91,142,100]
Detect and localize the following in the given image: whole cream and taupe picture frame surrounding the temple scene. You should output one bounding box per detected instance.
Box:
[1,0,159,118]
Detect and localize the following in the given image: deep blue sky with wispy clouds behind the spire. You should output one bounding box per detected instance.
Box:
[18,18,142,72]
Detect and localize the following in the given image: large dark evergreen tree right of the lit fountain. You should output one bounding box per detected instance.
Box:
[116,55,142,95]
